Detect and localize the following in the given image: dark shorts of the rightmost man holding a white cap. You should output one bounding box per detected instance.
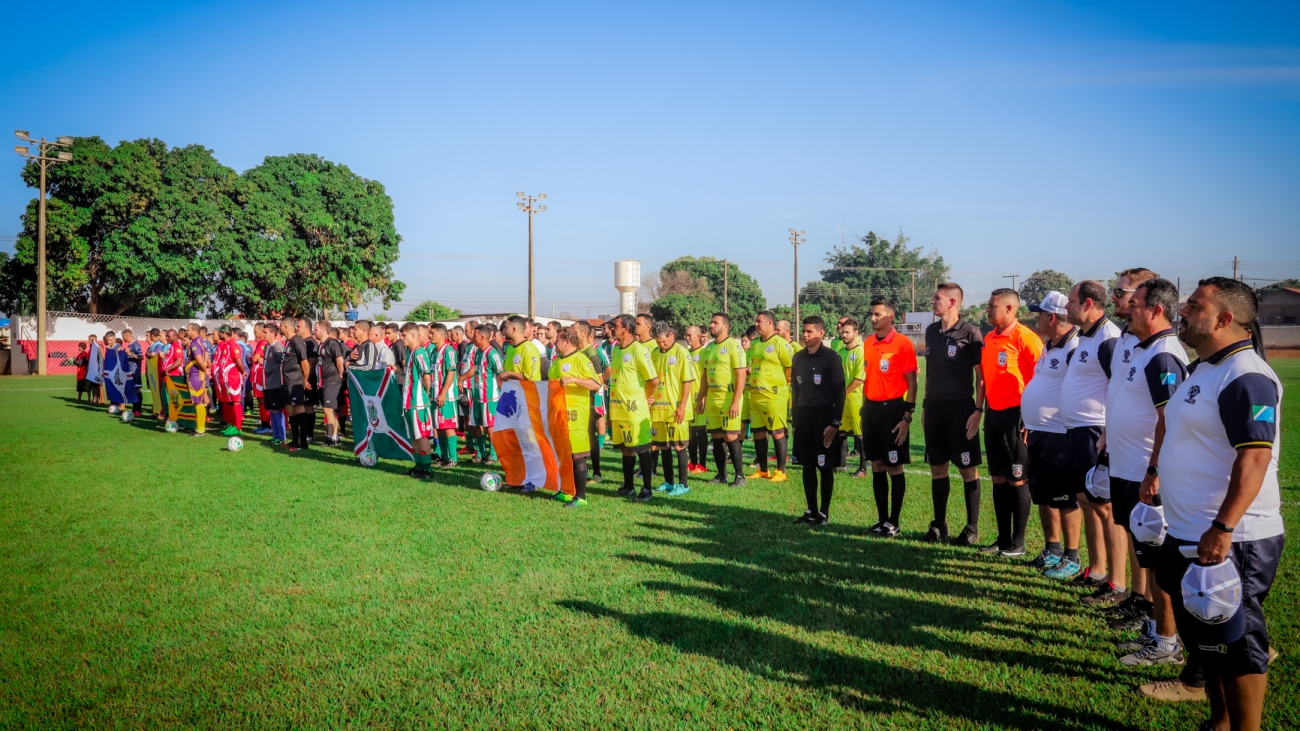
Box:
[1156,536,1286,678]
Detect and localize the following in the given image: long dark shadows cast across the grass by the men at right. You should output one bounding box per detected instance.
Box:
[558,501,1132,730]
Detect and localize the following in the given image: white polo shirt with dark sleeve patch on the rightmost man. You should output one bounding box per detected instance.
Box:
[1160,339,1284,542]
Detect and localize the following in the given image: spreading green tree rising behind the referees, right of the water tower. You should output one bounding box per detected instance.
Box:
[800,232,949,323]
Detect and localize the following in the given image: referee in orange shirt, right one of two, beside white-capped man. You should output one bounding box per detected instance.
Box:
[979,289,1043,557]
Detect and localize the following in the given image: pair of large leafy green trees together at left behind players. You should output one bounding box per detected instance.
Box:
[0,137,404,317]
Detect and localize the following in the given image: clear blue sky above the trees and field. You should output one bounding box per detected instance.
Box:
[0,1,1300,315]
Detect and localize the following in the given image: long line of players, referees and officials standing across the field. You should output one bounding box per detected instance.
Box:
[78,268,1284,728]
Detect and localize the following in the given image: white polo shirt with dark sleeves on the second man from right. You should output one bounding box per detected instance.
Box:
[1106,328,1187,483]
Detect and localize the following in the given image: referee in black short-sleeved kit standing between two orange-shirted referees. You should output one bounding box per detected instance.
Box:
[920,282,984,546]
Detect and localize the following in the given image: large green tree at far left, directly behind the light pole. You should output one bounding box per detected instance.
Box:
[0,137,238,317]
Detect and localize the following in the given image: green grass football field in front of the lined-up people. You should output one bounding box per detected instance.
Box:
[0,360,1300,730]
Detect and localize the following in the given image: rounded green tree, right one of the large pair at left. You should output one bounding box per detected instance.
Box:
[216,155,406,317]
